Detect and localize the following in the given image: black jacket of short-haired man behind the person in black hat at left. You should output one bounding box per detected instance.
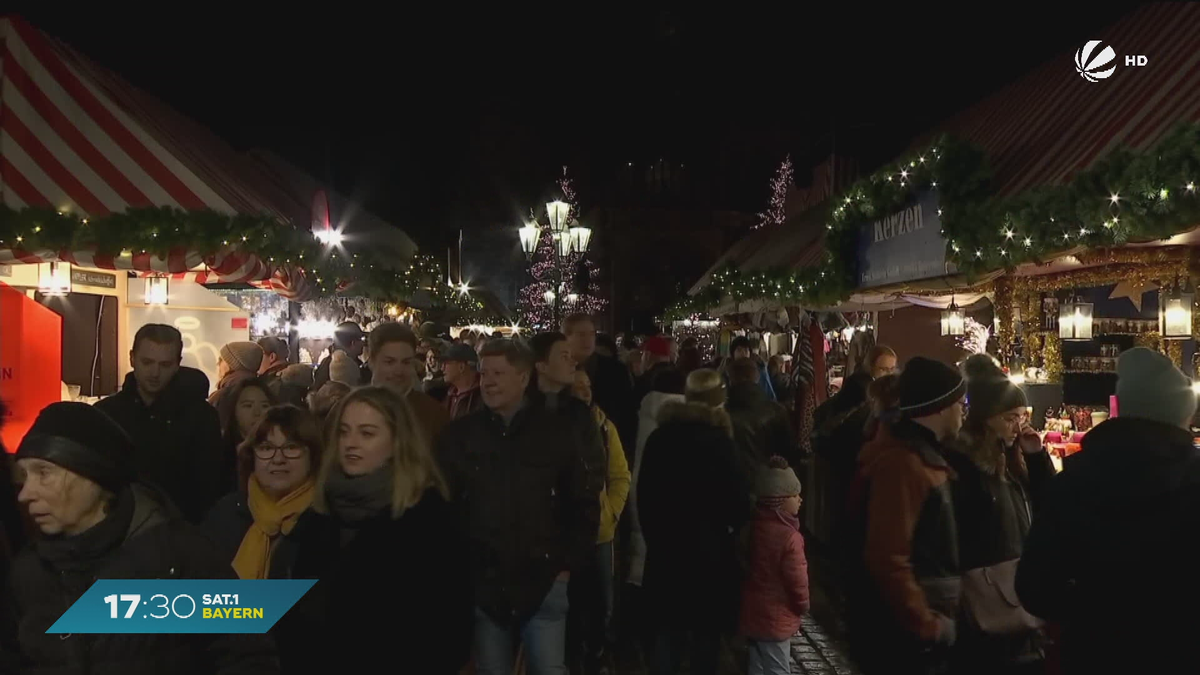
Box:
[96,366,224,522]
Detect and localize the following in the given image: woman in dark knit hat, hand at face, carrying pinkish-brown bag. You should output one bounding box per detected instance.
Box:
[946,354,1054,674]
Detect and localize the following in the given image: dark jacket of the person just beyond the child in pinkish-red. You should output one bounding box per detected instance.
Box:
[725,384,799,477]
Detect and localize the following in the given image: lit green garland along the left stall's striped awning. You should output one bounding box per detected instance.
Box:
[0,205,484,315]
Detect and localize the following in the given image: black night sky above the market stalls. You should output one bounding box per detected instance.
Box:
[14,2,1133,247]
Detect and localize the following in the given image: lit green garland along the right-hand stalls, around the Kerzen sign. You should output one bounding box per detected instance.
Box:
[666,123,1200,319]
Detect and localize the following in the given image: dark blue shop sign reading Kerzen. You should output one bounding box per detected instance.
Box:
[857,192,958,288]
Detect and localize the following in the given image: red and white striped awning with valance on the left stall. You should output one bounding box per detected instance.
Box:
[0,17,311,298]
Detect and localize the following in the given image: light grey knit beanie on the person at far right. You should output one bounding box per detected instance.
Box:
[1117,347,1196,429]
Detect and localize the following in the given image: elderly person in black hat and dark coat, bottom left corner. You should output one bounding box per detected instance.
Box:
[0,402,278,675]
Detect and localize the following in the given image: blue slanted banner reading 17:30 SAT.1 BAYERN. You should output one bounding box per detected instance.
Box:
[47,579,317,634]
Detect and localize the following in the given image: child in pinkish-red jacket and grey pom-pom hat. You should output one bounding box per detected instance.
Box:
[739,456,809,675]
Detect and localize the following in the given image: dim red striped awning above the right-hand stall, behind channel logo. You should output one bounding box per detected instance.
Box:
[913,2,1200,196]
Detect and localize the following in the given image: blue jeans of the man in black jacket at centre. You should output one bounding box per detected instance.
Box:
[475,580,568,675]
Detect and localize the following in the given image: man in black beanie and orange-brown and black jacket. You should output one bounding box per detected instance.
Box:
[847,357,966,674]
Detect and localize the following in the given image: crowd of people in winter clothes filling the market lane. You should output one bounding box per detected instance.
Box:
[0,315,1200,675]
